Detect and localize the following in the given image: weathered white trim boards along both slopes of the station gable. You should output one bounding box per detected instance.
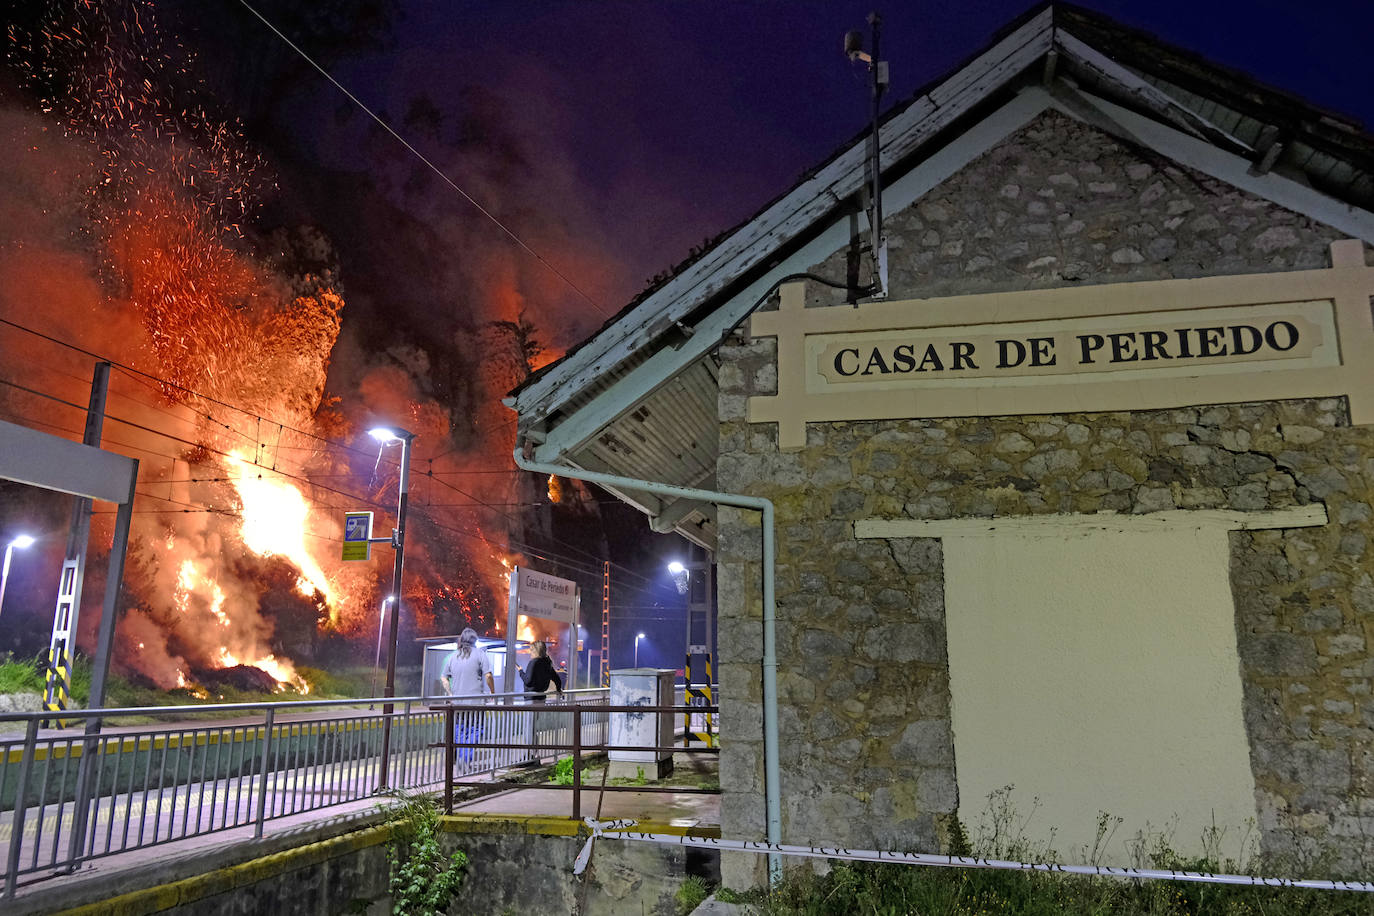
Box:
[513,8,1374,472]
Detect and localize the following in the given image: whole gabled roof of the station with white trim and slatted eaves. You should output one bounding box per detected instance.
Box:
[507,3,1374,545]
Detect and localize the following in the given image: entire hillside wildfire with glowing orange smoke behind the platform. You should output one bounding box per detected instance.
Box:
[0,0,585,688]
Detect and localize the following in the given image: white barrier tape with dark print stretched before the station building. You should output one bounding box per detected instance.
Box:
[573,817,1374,893]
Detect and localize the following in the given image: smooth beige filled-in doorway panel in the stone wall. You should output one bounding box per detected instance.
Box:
[944,526,1256,864]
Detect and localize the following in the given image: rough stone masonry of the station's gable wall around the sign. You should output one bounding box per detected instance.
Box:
[717,114,1374,886]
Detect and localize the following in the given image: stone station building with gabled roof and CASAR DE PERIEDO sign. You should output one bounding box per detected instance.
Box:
[510,4,1374,886]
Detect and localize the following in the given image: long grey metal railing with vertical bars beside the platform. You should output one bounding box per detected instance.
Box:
[0,688,719,898]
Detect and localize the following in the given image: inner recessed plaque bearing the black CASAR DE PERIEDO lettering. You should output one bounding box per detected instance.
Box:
[808,314,1323,385]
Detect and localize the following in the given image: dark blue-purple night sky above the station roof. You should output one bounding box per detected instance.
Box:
[224,0,1374,343]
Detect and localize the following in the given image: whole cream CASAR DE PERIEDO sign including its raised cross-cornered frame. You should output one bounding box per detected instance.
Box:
[746,239,1374,450]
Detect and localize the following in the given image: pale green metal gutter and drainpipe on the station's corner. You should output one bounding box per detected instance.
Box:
[515,446,782,884]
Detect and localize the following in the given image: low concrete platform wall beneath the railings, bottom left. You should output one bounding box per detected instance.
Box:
[34,817,720,916]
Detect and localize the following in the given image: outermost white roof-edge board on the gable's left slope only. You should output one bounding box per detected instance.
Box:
[515,8,1054,422]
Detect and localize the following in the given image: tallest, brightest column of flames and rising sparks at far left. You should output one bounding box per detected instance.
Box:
[0,0,371,687]
